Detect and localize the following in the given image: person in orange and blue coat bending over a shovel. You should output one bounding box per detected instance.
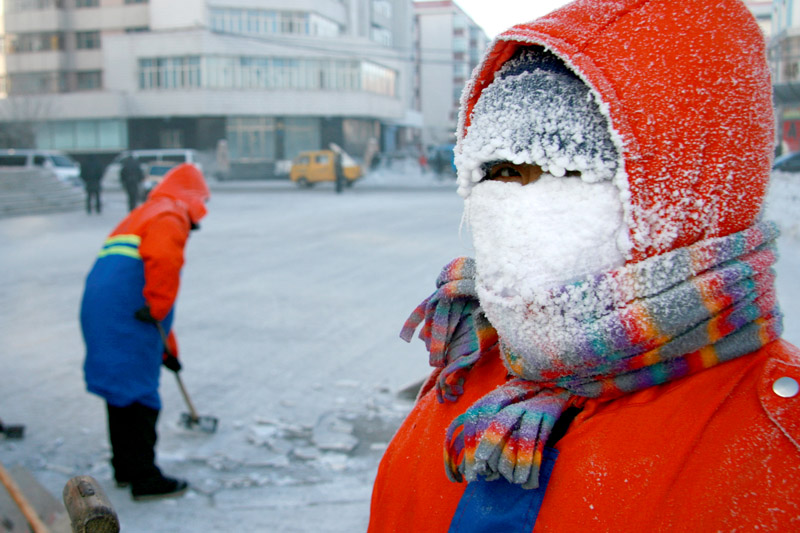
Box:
[80,164,210,499]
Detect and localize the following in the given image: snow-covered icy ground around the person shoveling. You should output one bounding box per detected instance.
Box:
[0,164,800,532]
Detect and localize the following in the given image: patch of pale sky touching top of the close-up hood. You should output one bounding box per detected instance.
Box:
[446,0,570,39]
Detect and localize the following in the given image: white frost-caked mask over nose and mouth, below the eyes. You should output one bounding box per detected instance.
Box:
[466,178,627,365]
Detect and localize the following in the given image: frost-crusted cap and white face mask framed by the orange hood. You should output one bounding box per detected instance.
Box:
[466,50,627,365]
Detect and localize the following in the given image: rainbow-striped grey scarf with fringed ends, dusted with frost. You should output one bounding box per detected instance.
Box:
[401,222,782,488]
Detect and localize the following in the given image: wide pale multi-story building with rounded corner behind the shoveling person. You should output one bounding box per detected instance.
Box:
[0,0,421,179]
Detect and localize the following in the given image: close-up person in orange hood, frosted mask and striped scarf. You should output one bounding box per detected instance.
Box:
[369,0,800,533]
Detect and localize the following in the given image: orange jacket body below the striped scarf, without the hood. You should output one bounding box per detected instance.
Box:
[369,341,800,533]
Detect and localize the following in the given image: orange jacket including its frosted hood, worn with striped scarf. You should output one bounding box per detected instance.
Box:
[369,0,800,533]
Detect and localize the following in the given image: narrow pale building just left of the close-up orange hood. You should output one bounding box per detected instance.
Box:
[414,0,488,145]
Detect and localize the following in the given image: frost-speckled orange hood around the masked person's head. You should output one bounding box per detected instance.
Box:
[456,0,773,262]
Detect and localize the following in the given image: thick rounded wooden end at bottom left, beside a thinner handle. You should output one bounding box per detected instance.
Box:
[64,476,120,533]
